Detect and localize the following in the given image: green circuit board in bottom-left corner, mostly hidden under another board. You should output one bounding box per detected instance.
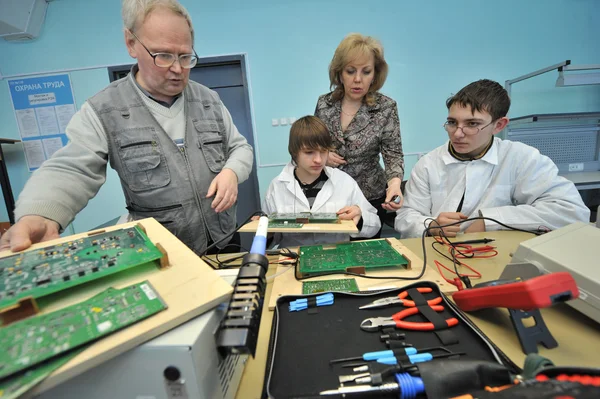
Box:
[0,346,86,399]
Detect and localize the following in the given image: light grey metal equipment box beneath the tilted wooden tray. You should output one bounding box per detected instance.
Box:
[37,304,248,399]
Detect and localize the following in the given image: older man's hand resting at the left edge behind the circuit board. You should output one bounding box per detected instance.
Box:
[0,215,60,252]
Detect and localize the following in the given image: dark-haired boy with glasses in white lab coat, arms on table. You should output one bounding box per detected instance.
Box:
[394,79,590,238]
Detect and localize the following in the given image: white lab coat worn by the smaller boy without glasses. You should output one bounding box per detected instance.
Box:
[263,163,381,247]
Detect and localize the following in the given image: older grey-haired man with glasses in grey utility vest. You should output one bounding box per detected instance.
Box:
[0,0,253,254]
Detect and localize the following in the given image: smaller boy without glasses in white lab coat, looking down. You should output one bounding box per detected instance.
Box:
[263,116,381,247]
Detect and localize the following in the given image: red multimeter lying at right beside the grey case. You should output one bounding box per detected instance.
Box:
[452,272,579,312]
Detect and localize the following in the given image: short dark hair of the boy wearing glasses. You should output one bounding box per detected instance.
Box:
[446,79,510,120]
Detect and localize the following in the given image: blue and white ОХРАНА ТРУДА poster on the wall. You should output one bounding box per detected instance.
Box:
[8,74,75,171]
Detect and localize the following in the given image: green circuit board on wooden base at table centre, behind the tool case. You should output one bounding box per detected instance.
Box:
[299,240,409,276]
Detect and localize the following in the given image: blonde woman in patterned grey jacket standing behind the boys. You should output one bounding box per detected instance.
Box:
[315,33,404,237]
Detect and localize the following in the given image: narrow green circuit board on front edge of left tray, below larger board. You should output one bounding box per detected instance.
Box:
[0,281,167,379]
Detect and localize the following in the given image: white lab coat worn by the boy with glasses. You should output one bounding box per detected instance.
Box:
[394,138,590,238]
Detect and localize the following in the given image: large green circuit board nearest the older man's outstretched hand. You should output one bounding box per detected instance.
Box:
[0,226,163,309]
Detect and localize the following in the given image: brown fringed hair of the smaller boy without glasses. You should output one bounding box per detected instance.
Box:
[288,115,333,160]
